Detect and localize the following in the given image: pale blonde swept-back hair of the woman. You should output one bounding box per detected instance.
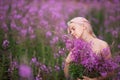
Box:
[67,17,96,37]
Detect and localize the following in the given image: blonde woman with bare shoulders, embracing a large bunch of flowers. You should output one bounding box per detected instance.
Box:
[64,17,111,80]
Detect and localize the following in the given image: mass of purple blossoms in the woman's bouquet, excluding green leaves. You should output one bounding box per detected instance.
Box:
[68,39,118,76]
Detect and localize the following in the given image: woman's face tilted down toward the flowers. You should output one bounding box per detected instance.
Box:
[68,23,84,39]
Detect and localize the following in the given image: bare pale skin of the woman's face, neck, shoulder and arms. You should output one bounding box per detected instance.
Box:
[64,22,111,80]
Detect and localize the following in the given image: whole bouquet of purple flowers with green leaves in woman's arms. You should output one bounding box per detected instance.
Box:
[66,39,118,79]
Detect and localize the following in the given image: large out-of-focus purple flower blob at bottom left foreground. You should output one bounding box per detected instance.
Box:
[19,64,32,78]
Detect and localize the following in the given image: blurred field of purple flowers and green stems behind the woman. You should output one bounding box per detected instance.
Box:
[0,0,120,80]
